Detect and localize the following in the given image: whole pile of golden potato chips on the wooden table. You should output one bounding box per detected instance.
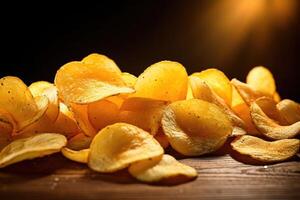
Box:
[0,54,300,182]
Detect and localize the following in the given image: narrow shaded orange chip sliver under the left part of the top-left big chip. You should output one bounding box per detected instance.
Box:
[68,103,97,136]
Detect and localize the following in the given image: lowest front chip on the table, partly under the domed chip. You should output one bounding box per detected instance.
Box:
[128,154,197,183]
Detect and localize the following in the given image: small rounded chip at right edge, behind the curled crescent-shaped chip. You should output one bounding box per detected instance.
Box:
[276,99,300,124]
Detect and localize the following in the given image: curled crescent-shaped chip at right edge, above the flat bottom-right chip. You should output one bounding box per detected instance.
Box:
[250,102,300,140]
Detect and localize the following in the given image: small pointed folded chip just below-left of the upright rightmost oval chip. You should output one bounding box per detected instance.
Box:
[231,78,266,106]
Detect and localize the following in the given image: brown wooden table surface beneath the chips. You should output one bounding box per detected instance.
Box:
[0,154,300,200]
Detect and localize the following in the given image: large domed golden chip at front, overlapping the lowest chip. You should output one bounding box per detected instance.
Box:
[88,123,164,172]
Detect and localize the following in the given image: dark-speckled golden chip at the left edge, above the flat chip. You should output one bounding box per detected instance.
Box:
[0,76,48,133]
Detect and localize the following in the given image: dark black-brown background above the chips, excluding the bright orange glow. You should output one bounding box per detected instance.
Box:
[0,0,300,102]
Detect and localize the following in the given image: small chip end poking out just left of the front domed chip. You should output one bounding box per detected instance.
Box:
[61,147,90,163]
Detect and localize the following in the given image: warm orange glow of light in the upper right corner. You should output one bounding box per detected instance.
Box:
[196,0,298,63]
